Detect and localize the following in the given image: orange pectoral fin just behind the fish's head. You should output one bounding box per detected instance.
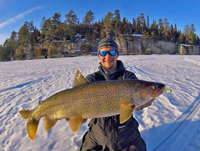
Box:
[120,104,135,124]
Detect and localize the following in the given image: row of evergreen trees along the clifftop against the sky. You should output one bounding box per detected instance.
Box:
[0,10,200,60]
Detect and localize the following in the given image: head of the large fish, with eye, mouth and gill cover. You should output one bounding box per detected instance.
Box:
[133,81,165,107]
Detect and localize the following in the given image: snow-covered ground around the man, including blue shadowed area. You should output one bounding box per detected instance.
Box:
[0,55,200,151]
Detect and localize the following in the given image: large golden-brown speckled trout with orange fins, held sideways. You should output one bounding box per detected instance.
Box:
[19,71,165,140]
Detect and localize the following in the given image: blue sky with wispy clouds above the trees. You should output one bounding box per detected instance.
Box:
[0,0,200,44]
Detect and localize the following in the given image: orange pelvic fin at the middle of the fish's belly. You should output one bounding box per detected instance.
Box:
[69,117,83,133]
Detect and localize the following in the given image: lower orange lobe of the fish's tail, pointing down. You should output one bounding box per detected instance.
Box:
[26,118,39,140]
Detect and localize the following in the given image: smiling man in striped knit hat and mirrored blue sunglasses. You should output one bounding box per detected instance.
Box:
[81,38,152,151]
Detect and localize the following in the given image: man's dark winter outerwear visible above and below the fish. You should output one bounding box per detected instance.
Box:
[81,60,146,151]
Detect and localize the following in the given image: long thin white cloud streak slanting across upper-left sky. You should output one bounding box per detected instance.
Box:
[0,7,44,29]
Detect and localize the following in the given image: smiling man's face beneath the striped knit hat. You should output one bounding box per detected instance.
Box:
[99,48,118,71]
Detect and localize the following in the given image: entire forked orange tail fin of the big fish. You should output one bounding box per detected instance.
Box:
[19,110,39,140]
